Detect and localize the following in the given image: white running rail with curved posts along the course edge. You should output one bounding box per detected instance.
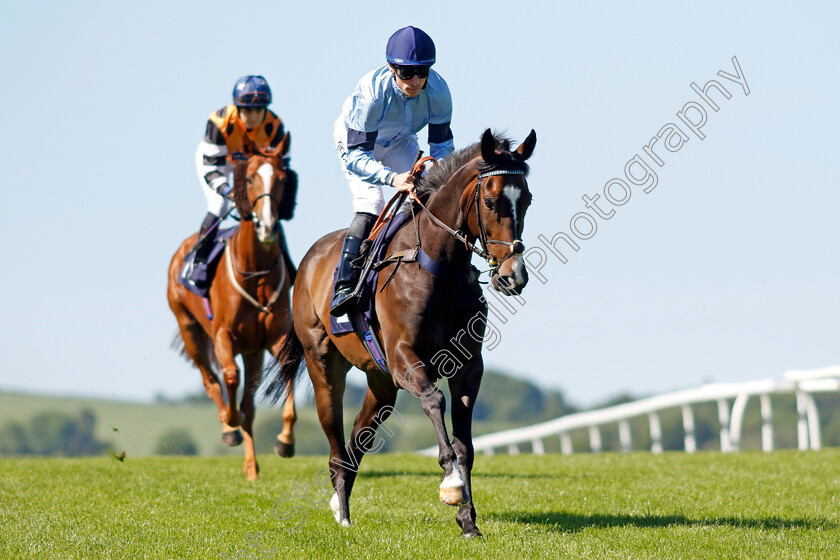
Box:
[418,365,840,456]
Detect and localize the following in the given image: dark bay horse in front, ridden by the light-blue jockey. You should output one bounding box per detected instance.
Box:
[267,129,536,537]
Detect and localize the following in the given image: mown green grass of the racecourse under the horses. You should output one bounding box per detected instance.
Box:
[0,449,840,560]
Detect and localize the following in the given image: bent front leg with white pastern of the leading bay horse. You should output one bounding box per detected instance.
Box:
[394,344,470,506]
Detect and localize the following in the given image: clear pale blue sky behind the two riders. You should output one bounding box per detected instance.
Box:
[0,1,840,404]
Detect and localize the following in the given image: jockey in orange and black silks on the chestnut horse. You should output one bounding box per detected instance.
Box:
[190,76,291,291]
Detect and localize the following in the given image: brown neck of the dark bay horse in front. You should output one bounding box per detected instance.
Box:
[419,164,475,267]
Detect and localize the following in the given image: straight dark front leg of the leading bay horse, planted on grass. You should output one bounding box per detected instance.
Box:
[449,360,483,537]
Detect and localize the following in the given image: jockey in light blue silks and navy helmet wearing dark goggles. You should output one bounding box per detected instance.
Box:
[330,26,455,316]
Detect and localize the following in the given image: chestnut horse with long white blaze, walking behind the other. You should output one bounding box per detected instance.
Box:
[167,134,297,480]
